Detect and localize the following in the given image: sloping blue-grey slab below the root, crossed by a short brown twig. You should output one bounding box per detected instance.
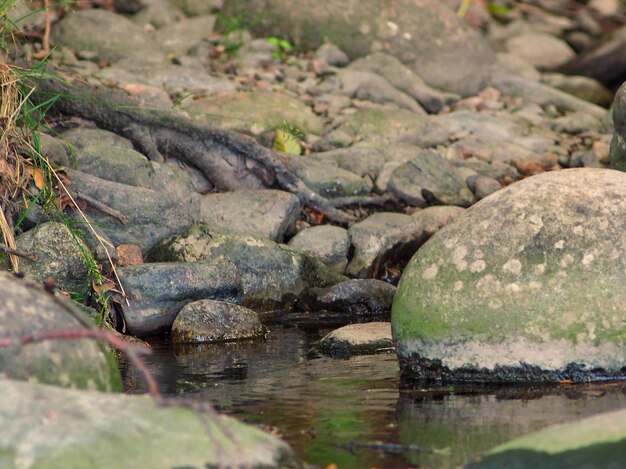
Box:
[66,169,192,253]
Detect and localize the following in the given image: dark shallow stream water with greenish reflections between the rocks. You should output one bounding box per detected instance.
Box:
[121,326,626,469]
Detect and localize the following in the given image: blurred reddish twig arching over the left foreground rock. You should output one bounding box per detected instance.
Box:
[0,329,164,404]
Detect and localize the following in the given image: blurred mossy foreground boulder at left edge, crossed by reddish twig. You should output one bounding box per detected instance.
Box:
[0,272,122,392]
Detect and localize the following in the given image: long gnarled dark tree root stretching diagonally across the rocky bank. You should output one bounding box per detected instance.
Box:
[33,75,355,224]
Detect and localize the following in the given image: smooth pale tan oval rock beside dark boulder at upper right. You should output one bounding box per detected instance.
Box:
[506,31,576,70]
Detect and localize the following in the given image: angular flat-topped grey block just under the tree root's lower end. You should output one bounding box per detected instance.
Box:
[195,189,300,241]
